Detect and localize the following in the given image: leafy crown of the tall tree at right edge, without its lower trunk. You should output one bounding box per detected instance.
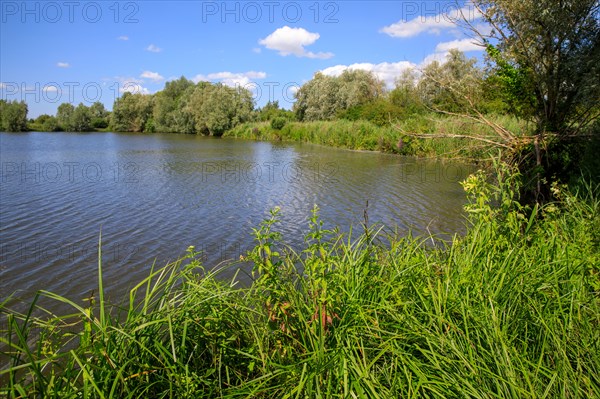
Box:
[473,0,600,137]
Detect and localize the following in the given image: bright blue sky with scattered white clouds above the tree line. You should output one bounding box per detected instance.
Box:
[0,0,482,118]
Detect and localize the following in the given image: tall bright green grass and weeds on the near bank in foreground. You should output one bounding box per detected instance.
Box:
[0,165,600,398]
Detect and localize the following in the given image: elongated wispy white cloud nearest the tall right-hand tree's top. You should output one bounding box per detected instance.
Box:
[380,3,481,38]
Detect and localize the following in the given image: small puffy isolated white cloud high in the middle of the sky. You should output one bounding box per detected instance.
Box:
[258,26,333,59]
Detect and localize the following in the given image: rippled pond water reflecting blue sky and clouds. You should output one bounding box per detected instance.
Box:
[0,133,470,310]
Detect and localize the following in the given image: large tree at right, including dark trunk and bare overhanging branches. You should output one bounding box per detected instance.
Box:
[408,0,600,202]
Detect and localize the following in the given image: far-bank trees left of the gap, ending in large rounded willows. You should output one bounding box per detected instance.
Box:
[0,77,256,136]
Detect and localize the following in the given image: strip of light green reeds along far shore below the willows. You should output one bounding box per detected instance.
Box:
[223,113,526,161]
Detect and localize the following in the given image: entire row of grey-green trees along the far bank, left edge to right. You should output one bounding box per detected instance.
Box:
[0,50,506,136]
